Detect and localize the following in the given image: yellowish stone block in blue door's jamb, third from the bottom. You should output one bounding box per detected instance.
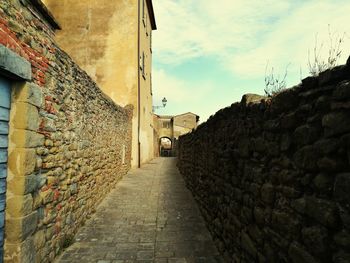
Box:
[6,194,33,217]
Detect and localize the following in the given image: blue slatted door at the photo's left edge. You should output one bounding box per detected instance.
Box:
[0,76,11,262]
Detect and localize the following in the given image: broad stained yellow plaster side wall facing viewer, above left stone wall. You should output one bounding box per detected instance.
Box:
[45,0,138,106]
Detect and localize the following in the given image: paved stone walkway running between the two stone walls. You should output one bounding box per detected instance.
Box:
[57,158,222,263]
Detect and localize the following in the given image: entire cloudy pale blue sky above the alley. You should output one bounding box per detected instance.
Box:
[152,0,350,121]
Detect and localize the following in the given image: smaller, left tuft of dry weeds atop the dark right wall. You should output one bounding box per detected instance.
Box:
[264,62,289,97]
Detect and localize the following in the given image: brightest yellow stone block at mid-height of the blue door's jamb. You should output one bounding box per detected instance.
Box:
[8,148,36,176]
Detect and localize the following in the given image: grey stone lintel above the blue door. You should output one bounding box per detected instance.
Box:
[0,44,32,80]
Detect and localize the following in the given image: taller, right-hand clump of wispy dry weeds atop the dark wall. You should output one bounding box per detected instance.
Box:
[308,25,346,76]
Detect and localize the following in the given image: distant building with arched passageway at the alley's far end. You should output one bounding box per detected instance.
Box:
[154,112,199,156]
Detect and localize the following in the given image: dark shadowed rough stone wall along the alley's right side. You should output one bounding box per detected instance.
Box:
[178,59,350,263]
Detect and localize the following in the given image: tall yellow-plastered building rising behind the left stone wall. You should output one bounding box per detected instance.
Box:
[44,0,156,167]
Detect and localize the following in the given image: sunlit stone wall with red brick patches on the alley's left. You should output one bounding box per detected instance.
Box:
[0,0,133,262]
